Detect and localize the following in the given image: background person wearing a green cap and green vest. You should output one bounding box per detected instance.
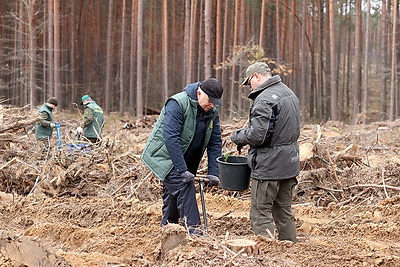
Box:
[77,95,104,144]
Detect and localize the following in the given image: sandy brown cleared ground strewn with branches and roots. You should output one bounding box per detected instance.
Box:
[0,106,400,266]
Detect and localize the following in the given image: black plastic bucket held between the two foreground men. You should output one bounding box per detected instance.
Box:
[217,156,250,191]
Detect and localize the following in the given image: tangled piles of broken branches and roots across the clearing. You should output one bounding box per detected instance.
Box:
[0,106,400,206]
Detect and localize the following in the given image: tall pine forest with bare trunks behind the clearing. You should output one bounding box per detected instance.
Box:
[0,0,400,124]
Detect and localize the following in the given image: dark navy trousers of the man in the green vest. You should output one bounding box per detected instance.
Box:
[161,170,201,233]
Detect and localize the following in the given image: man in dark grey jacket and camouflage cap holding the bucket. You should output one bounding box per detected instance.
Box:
[231,62,300,242]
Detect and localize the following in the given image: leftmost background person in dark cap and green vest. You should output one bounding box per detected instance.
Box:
[35,97,58,142]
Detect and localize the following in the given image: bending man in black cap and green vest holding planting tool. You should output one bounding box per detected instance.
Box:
[142,78,223,234]
